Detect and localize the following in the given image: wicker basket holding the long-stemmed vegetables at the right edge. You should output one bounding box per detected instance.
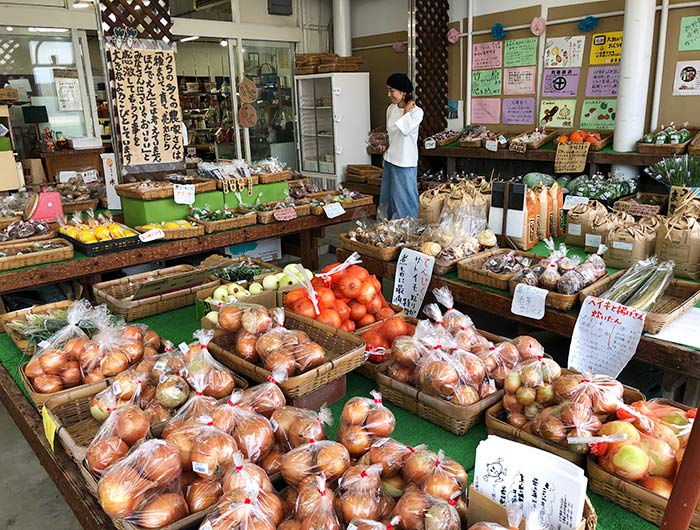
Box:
[581,271,700,334]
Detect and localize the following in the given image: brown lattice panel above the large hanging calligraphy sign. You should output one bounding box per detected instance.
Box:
[100,0,173,42]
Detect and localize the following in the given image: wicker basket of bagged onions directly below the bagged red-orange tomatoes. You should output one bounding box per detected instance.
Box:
[209,311,365,399]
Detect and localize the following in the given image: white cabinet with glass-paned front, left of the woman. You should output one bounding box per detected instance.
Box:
[296,72,371,189]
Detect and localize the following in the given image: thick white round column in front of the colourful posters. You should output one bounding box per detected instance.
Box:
[613,0,656,169]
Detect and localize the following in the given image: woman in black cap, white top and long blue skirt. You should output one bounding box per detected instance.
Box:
[379,73,423,219]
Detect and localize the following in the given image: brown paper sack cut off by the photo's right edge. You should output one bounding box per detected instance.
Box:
[656,214,700,280]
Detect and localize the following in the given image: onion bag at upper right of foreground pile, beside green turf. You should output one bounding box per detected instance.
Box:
[338,390,396,459]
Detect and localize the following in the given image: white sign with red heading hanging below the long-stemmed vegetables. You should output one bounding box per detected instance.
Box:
[569,296,646,377]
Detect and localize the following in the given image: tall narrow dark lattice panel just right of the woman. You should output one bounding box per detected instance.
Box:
[415,0,449,141]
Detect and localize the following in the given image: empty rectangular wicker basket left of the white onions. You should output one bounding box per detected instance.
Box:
[93,265,219,322]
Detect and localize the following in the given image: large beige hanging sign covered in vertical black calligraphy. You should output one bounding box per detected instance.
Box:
[108,46,185,171]
